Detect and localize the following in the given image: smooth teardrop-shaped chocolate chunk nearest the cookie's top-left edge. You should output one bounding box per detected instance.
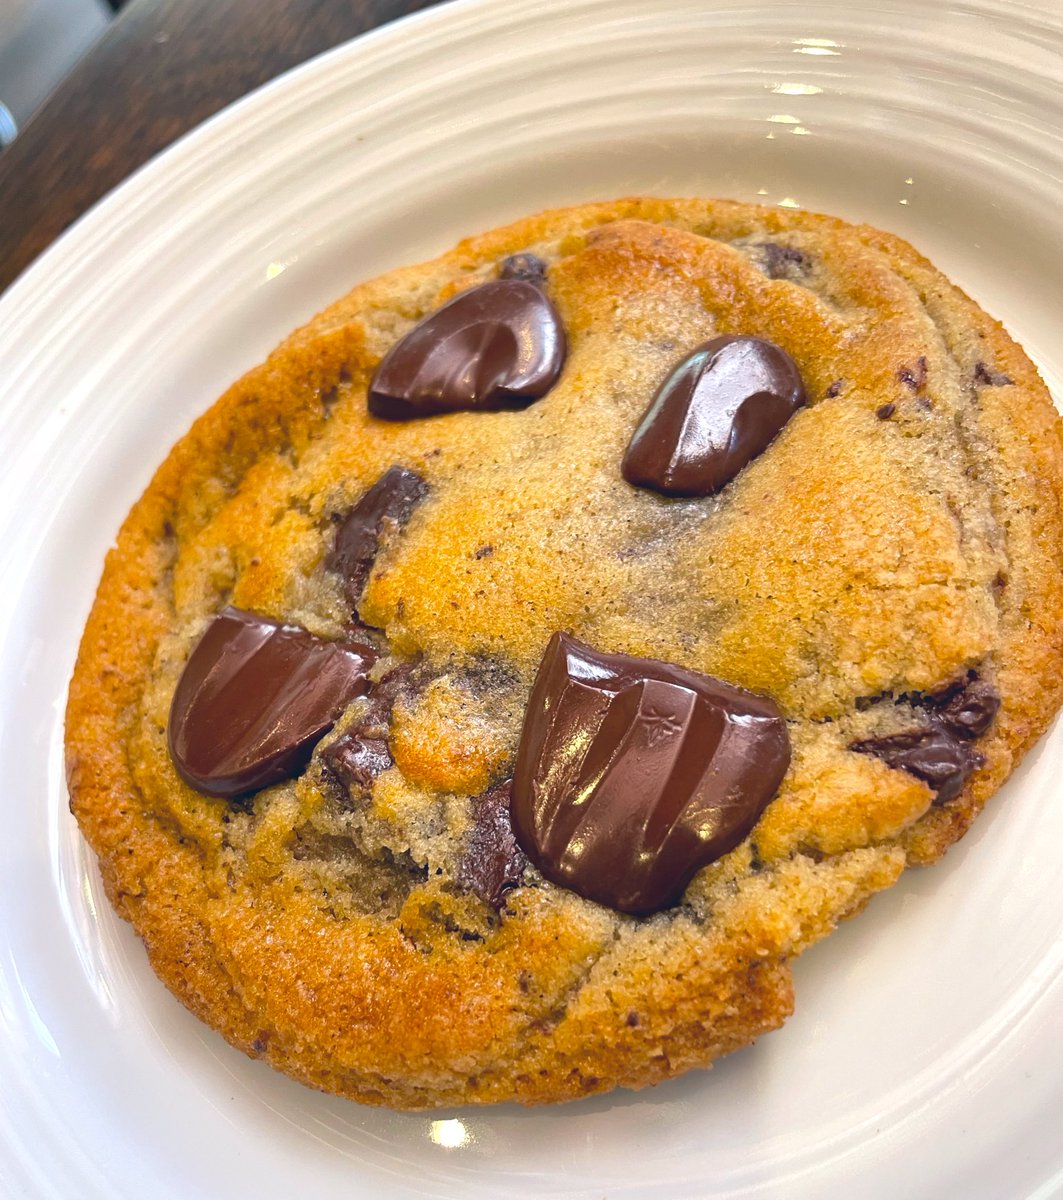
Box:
[368,280,566,421]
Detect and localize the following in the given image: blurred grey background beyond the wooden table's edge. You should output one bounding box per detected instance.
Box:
[0,0,121,145]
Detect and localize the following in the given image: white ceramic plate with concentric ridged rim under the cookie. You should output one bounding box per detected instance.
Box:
[0,0,1063,1200]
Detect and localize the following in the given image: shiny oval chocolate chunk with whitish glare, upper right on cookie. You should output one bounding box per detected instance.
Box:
[621,335,805,496]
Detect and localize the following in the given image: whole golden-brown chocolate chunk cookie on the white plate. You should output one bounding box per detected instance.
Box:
[66,199,1063,1109]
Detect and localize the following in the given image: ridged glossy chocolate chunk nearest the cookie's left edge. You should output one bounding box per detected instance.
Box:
[168,607,377,797]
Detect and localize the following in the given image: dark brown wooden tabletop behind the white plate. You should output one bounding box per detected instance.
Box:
[0,0,440,292]
